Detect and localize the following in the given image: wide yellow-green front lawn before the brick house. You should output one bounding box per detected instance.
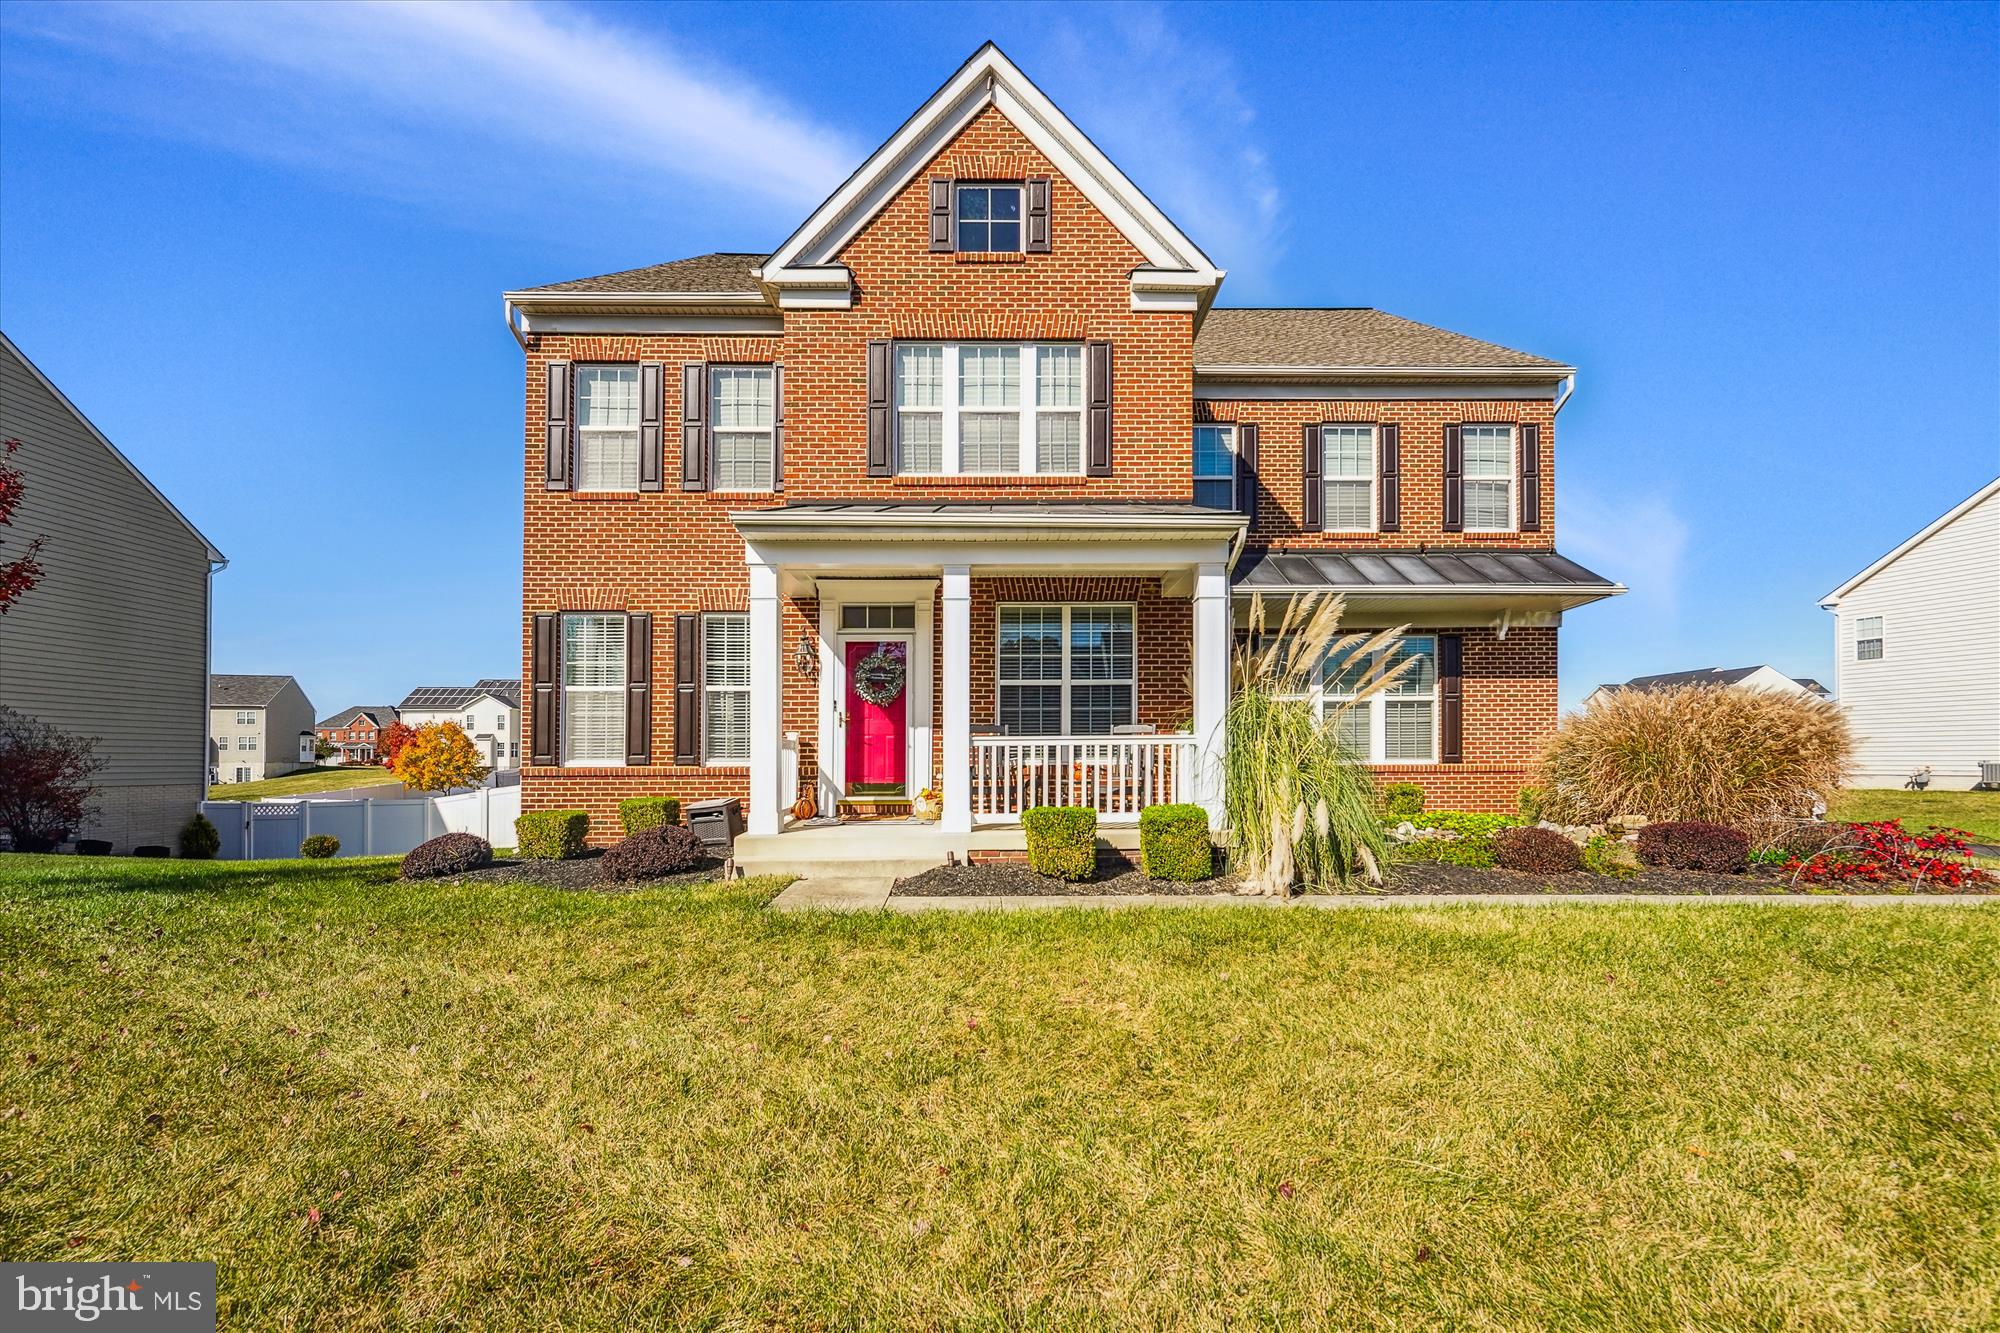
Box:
[0,857,2000,1331]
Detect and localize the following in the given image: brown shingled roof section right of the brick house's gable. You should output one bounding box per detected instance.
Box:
[1194,306,1570,376]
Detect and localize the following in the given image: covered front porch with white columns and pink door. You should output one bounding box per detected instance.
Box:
[732,502,1242,841]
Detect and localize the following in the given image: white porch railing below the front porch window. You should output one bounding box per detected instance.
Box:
[972,733,1194,821]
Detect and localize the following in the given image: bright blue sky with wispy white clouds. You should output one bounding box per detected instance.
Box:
[0,2,2000,713]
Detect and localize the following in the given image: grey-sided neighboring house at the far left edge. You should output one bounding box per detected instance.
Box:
[0,334,224,851]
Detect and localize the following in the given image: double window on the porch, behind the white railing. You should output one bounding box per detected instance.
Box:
[998,606,1138,737]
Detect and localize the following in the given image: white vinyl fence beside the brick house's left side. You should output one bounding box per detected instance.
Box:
[202,787,520,861]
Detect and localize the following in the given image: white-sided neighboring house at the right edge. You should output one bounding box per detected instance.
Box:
[1820,478,2000,791]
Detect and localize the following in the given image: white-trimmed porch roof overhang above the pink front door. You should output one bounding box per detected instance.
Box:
[730,500,1244,596]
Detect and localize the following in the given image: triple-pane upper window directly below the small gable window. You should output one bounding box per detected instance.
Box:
[894,342,1084,474]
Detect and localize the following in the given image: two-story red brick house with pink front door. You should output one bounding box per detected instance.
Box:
[506,44,1622,859]
